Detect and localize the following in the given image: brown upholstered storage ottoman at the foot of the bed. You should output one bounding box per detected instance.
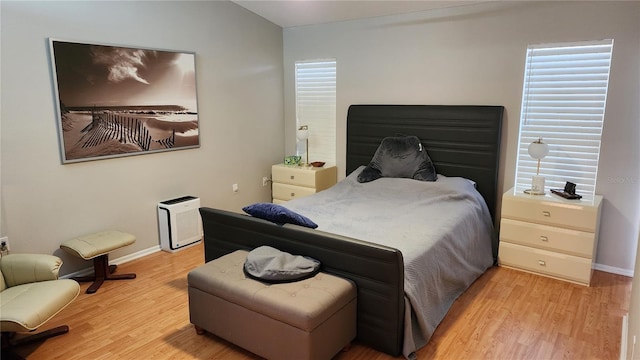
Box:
[187,250,356,360]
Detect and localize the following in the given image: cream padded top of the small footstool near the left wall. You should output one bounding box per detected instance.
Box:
[60,230,136,260]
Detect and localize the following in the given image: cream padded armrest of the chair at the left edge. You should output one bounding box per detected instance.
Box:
[0,254,62,287]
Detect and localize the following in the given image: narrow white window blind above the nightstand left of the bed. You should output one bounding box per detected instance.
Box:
[295,59,336,164]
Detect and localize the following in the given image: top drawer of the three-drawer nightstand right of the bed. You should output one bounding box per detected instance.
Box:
[502,196,599,232]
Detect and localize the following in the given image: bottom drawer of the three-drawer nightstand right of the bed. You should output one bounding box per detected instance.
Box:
[498,242,591,285]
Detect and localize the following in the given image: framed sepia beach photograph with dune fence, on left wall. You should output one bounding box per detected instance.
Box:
[50,39,200,163]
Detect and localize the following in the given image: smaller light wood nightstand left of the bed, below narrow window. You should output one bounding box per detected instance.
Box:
[271,164,338,204]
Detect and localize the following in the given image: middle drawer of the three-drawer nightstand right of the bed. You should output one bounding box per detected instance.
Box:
[500,218,596,259]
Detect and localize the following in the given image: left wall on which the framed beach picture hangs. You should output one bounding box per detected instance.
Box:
[0,1,284,273]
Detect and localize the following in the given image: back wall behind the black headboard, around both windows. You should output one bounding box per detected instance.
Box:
[284,1,640,275]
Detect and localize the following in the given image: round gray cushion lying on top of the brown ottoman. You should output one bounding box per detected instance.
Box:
[244,246,320,283]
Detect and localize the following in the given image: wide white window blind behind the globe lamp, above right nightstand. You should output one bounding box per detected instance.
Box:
[516,40,613,196]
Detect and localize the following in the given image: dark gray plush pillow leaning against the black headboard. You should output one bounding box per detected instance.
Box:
[358,136,437,183]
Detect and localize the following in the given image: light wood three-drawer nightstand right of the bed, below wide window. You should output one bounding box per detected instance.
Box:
[498,189,602,286]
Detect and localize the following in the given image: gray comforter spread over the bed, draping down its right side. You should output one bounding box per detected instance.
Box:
[283,168,493,358]
